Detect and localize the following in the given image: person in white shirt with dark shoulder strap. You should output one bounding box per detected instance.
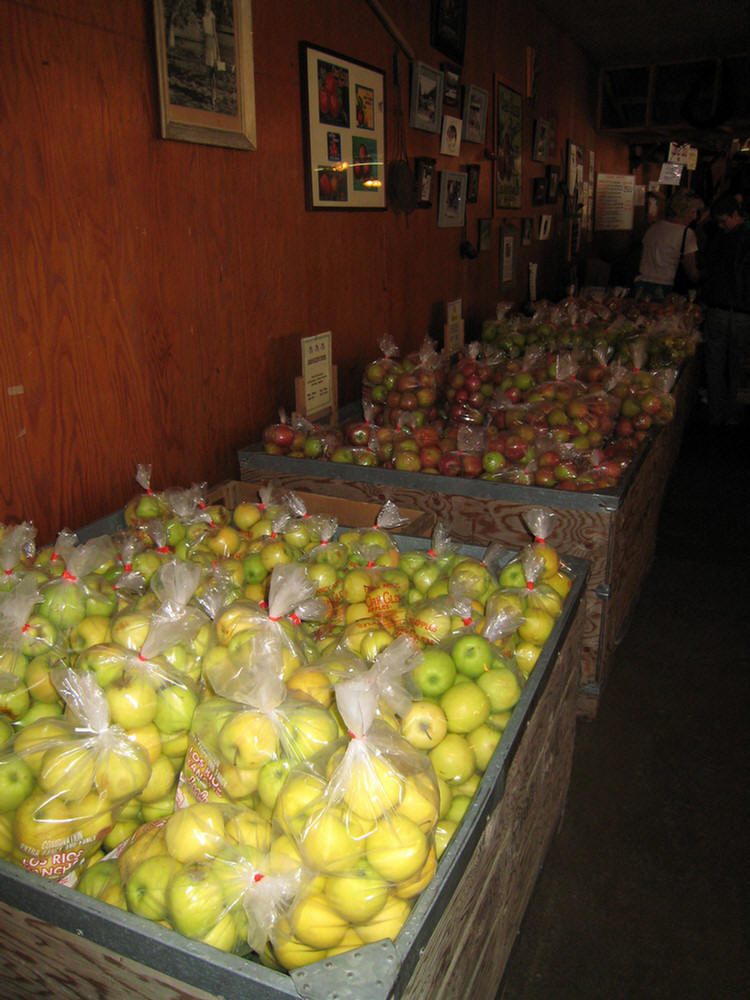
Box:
[633,190,705,301]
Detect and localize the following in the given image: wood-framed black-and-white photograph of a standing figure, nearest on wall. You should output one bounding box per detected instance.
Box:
[154,0,257,149]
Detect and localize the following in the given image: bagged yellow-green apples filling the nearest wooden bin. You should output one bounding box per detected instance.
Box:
[0,488,572,969]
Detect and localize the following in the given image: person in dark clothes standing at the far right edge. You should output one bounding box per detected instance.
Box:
[701,194,750,427]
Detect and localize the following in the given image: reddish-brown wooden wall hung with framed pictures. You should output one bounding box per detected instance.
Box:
[0,0,627,542]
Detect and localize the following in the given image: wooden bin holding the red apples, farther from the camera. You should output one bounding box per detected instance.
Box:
[238,361,695,718]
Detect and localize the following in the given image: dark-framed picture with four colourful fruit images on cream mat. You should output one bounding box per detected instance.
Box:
[300,42,386,211]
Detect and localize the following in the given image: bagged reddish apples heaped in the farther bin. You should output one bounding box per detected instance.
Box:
[263,301,699,491]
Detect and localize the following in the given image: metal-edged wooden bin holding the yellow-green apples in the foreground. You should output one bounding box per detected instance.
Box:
[0,537,589,1000]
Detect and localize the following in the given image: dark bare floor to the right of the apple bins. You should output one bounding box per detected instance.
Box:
[497,405,750,1000]
